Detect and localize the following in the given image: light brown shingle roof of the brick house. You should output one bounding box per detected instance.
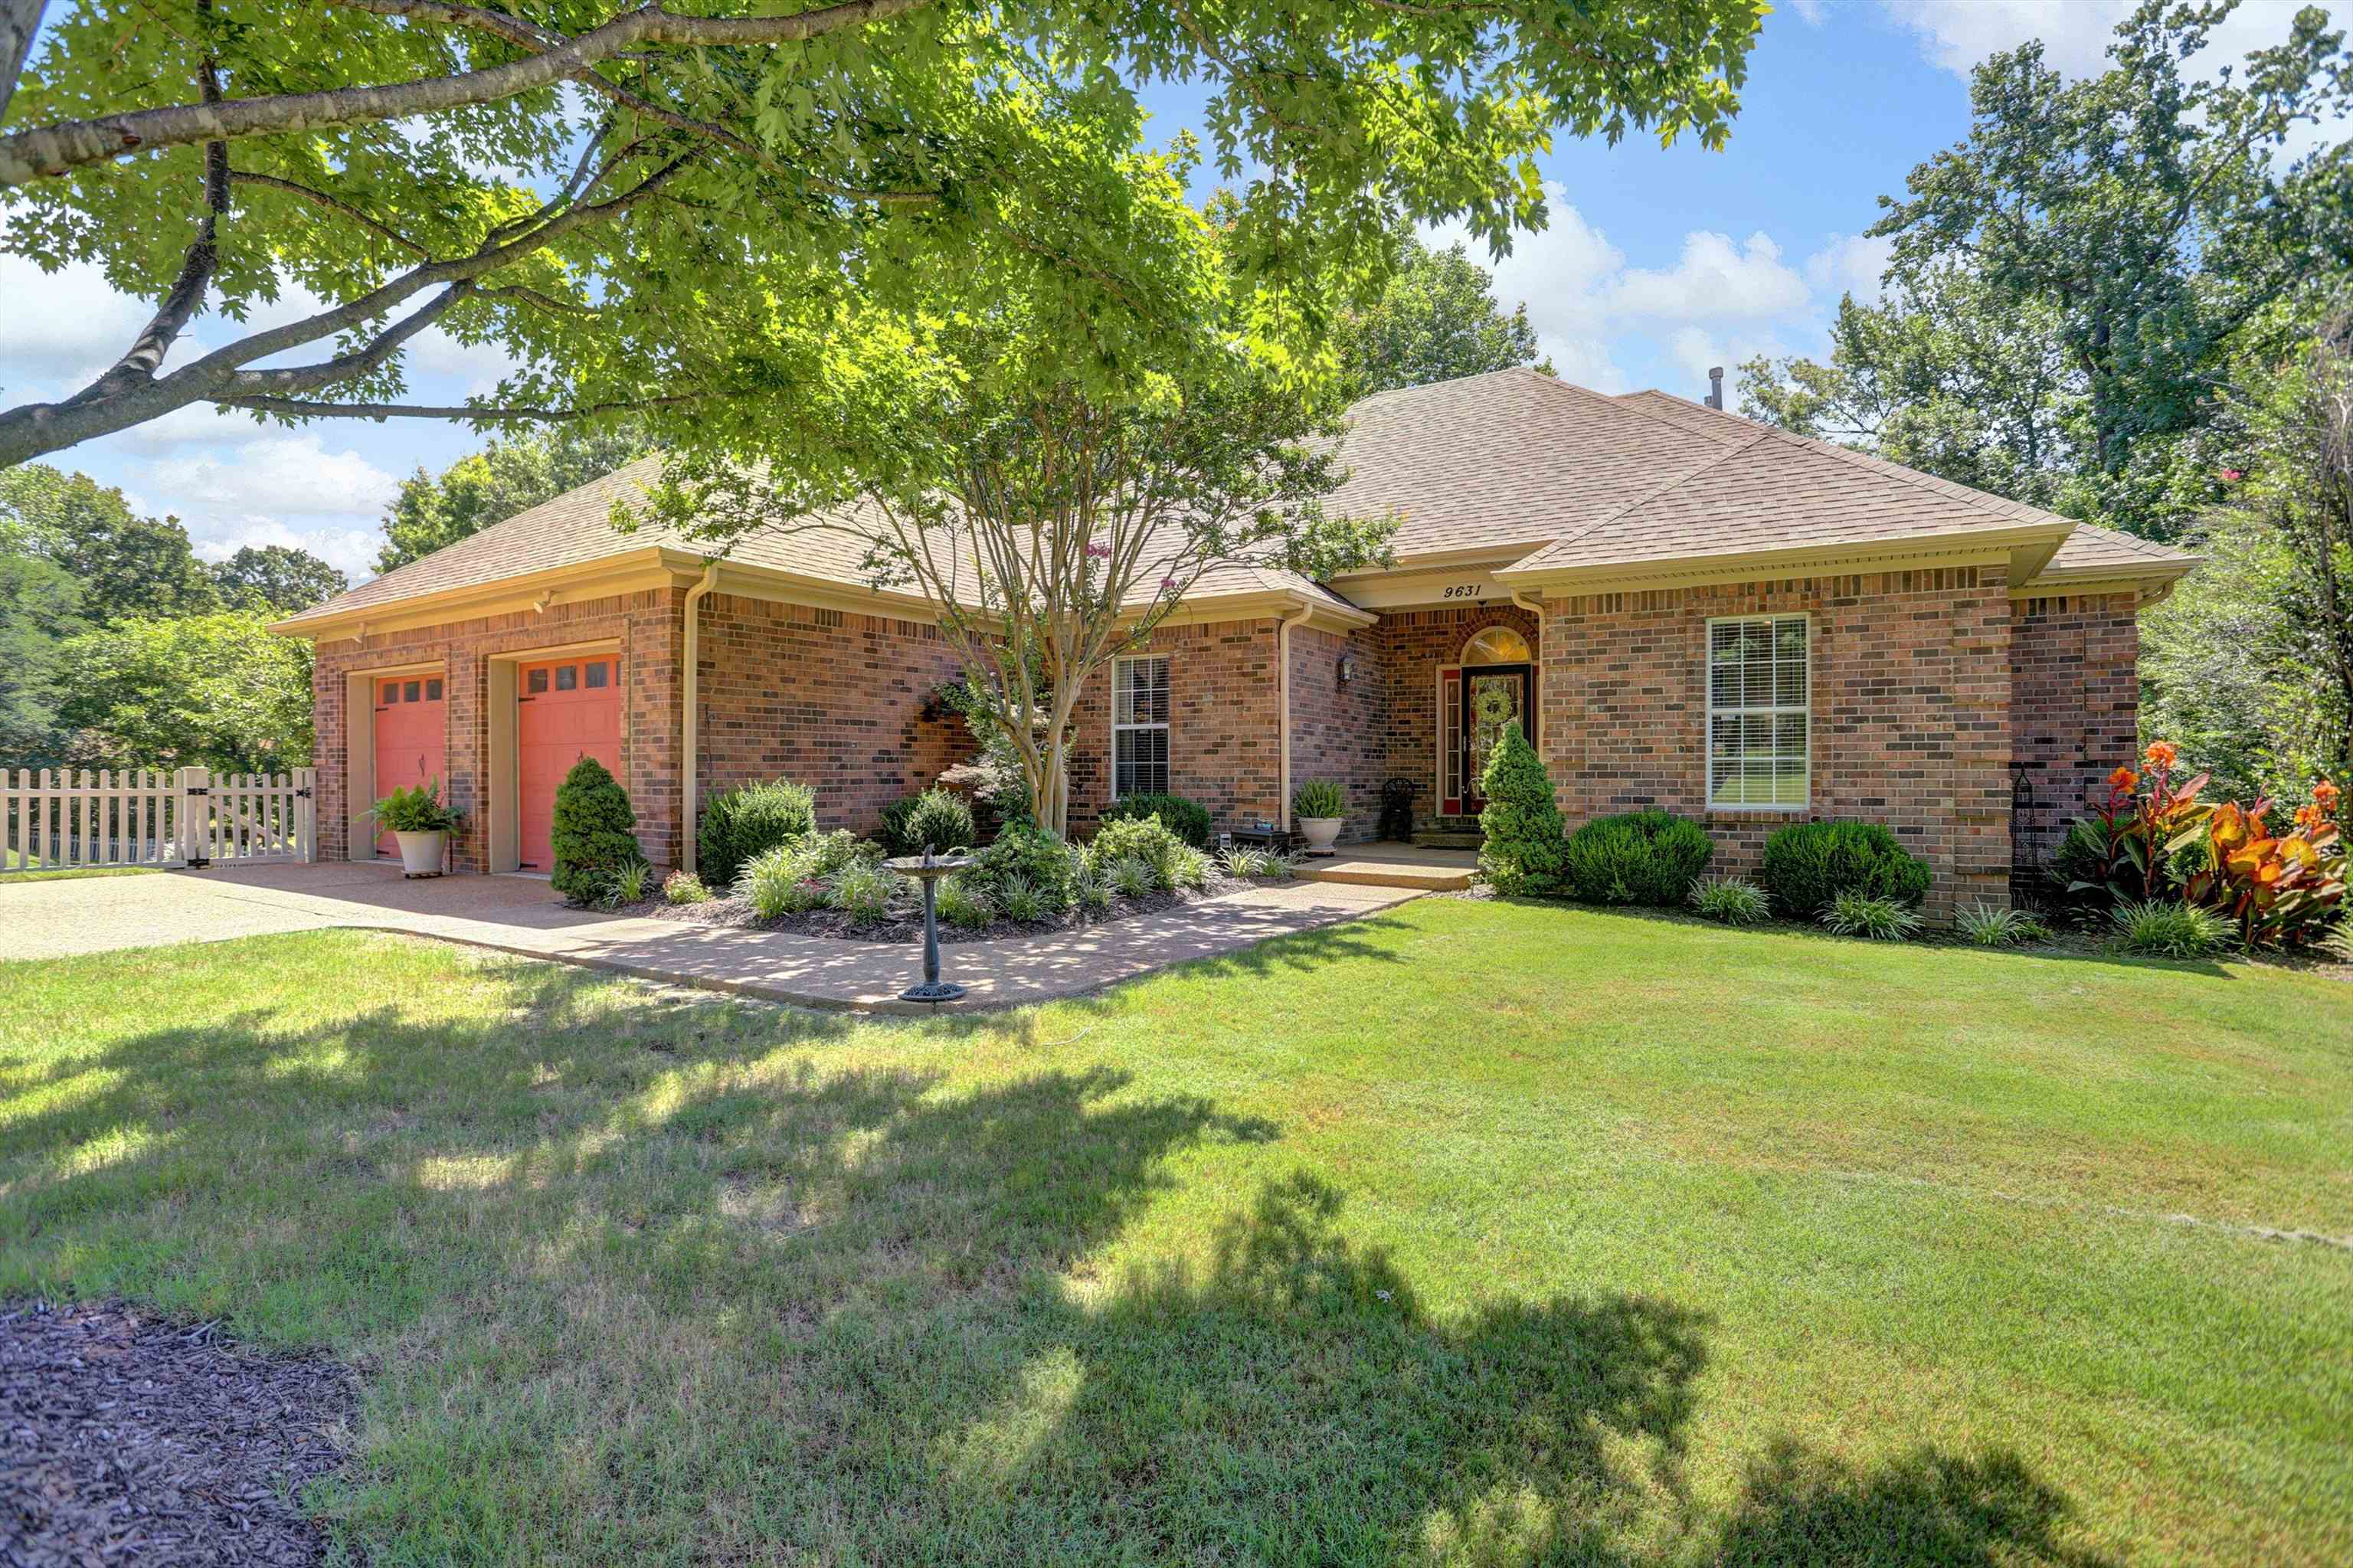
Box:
[292,370,2195,627]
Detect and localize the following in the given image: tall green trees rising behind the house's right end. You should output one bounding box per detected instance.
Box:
[1741,0,2353,800]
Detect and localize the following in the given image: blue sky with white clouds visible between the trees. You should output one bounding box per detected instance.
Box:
[0,0,2299,577]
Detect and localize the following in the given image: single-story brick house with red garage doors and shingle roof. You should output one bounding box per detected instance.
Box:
[277,370,2193,908]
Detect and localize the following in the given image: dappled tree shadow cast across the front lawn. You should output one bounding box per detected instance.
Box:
[0,965,2092,1566]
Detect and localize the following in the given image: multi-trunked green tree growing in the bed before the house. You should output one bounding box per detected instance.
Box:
[617,178,1396,833]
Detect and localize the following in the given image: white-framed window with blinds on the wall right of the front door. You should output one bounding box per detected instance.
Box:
[1708,614,1815,812]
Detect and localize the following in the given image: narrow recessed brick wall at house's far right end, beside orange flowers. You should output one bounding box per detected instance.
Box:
[2009,594,2142,869]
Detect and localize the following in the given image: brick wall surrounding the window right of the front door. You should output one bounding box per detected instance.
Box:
[1536,568,2012,918]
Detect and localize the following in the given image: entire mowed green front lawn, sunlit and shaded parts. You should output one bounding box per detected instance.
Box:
[0,899,2353,1566]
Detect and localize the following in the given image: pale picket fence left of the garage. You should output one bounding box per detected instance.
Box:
[0,768,318,876]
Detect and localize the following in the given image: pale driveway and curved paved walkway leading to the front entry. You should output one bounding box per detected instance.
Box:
[0,864,1414,1013]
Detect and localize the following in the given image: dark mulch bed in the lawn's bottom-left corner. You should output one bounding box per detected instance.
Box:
[0,1302,358,1568]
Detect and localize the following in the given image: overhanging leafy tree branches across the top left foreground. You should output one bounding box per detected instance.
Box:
[0,0,1765,466]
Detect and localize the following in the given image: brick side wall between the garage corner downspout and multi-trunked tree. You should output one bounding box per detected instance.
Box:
[696,594,974,833]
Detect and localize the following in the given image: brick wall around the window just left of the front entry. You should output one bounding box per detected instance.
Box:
[1071,619,1297,836]
